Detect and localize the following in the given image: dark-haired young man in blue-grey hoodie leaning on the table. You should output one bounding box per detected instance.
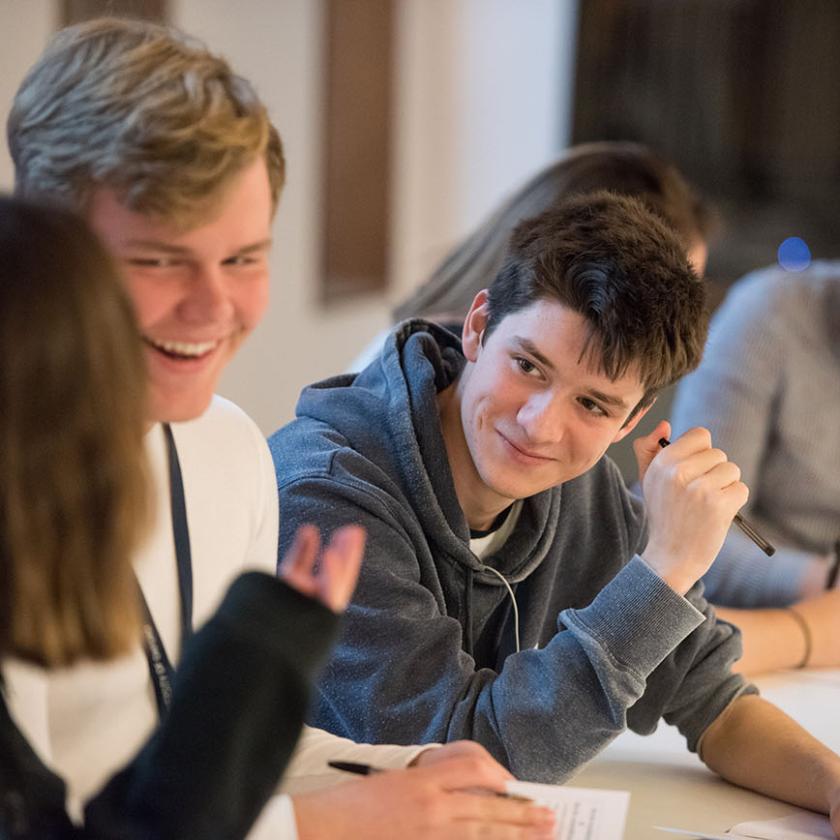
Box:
[271,193,840,831]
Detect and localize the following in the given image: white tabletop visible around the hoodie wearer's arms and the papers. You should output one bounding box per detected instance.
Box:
[569,670,840,840]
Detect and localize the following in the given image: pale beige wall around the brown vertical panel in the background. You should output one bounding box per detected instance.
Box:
[0,0,576,433]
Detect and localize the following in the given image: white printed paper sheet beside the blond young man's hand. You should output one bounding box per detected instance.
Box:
[508,782,630,840]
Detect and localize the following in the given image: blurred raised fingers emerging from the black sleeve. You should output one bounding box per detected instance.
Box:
[278,525,365,613]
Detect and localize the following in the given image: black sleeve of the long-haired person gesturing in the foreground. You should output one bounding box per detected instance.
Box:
[85,572,338,840]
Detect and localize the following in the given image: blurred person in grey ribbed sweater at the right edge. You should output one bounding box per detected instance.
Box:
[673,262,840,671]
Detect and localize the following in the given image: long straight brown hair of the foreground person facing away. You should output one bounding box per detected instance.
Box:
[0,197,149,666]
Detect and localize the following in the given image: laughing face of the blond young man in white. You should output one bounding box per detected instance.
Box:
[88,159,272,422]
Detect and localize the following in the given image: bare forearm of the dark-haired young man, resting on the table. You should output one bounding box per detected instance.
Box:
[701,696,840,814]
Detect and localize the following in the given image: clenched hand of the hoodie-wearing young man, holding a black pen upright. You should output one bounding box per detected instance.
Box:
[634,421,749,594]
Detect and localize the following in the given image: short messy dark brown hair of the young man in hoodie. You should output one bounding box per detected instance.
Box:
[484,192,708,407]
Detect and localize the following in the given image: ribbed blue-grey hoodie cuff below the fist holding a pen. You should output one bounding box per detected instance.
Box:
[560,555,706,677]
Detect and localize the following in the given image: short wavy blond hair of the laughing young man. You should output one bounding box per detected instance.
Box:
[7,18,284,227]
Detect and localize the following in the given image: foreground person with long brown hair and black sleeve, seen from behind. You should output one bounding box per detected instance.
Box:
[0,197,355,840]
